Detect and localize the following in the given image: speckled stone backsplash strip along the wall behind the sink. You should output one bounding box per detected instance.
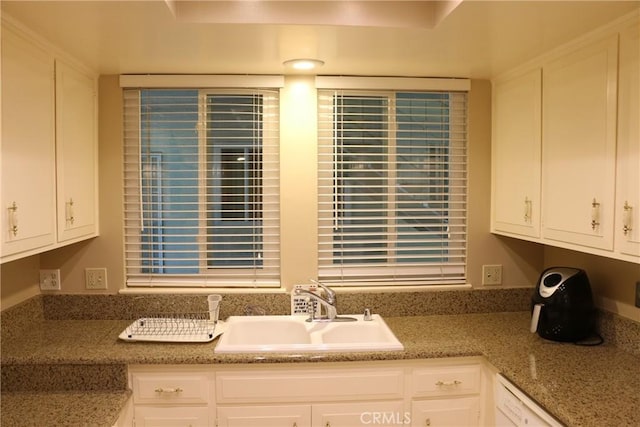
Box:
[0,288,640,355]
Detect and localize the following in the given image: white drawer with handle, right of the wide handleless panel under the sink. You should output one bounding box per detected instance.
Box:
[412,365,482,397]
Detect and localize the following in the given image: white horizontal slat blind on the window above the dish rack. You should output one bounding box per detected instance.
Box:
[124,89,280,286]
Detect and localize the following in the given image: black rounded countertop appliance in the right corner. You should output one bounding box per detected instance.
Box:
[531,267,595,342]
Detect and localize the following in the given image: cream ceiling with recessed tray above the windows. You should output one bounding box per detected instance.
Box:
[1,0,640,78]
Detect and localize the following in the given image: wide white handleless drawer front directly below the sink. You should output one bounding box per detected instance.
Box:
[216,369,404,403]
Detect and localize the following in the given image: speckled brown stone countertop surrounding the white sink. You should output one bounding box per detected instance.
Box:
[1,291,640,427]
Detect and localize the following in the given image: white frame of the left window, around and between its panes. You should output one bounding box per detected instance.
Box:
[124,87,280,288]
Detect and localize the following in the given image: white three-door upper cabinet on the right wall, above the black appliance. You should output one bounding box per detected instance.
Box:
[491,14,640,263]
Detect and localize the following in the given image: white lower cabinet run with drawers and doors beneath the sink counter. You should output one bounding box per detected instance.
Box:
[129,358,493,427]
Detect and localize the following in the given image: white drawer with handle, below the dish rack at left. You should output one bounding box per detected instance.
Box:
[131,372,213,405]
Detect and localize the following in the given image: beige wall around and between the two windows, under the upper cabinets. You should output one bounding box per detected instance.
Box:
[0,76,640,318]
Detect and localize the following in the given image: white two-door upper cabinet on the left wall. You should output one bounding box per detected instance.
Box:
[0,17,98,262]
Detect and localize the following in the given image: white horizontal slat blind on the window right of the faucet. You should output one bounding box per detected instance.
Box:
[318,90,467,285]
